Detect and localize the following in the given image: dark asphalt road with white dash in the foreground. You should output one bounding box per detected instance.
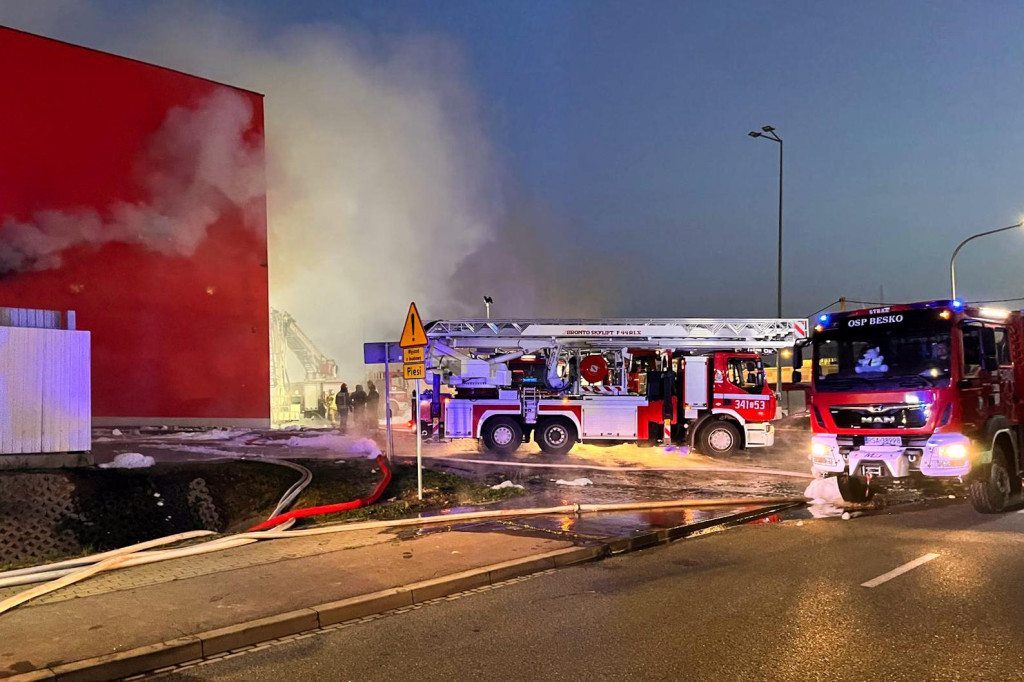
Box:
[157,505,1024,682]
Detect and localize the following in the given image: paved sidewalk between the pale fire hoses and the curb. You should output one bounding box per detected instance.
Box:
[0,520,587,679]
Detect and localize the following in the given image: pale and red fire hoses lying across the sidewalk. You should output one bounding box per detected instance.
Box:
[0,456,806,614]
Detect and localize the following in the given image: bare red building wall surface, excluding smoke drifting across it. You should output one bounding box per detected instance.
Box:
[0,27,269,424]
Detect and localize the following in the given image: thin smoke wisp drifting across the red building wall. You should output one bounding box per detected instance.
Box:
[0,90,264,273]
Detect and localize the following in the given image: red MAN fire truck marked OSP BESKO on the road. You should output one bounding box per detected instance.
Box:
[798,300,1024,513]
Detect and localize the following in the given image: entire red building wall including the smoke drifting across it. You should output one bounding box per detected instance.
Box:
[0,28,269,424]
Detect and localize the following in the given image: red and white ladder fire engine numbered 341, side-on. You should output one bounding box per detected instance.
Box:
[411,318,807,455]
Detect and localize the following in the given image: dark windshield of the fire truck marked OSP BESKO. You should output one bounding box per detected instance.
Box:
[814,310,952,392]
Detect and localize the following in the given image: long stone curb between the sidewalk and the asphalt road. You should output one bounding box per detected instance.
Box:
[0,503,800,682]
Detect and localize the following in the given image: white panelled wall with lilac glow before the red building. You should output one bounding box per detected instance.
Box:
[0,327,92,455]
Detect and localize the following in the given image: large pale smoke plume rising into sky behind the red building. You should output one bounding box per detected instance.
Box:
[0,2,615,380]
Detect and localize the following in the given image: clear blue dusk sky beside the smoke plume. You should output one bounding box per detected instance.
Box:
[6,0,1024,325]
